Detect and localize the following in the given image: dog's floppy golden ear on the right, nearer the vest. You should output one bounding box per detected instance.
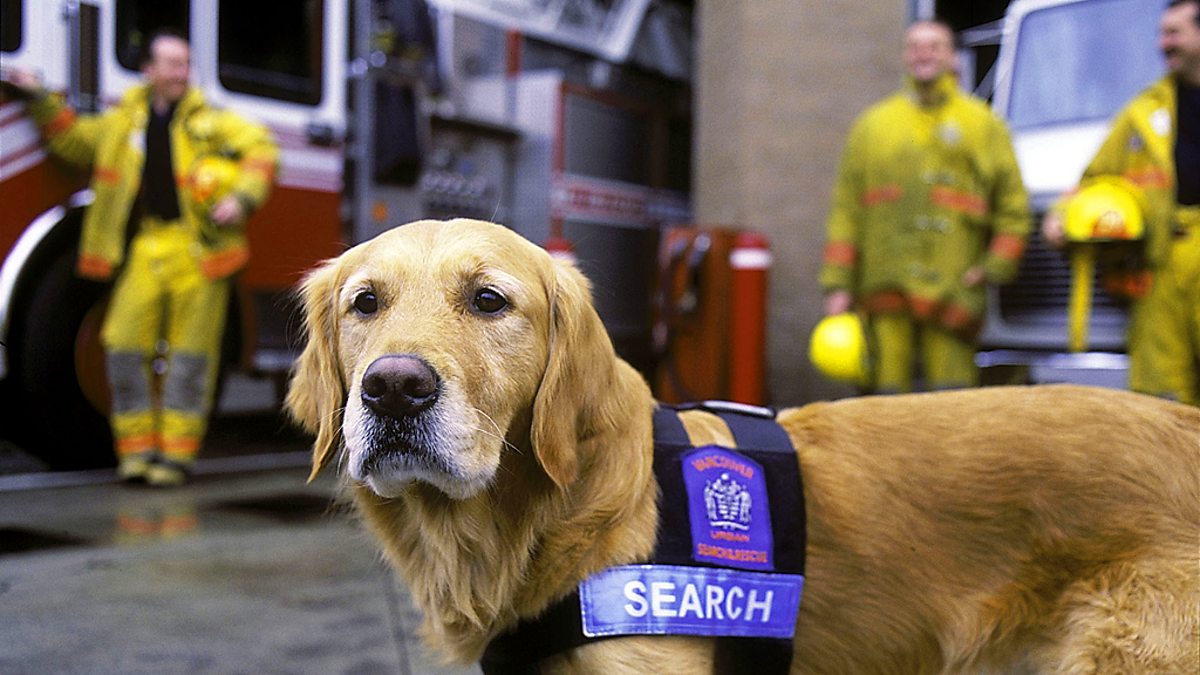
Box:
[532,261,616,488]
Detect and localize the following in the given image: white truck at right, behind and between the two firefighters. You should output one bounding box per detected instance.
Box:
[978,0,1164,387]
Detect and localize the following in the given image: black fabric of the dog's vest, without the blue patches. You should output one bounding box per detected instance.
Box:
[480,402,805,675]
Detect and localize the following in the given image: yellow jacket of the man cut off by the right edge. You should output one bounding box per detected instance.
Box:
[1080,76,1177,269]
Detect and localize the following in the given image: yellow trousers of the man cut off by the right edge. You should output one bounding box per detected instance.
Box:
[1129,207,1200,406]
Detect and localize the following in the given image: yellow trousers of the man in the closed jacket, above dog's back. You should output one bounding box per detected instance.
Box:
[869,312,979,394]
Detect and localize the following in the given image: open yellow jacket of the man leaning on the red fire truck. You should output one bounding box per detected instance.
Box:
[29,85,278,280]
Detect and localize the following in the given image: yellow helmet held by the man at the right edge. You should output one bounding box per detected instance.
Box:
[1063,178,1146,243]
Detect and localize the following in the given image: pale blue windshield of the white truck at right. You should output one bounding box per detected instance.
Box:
[1006,0,1164,130]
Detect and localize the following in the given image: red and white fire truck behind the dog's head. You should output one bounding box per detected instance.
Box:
[0,0,690,468]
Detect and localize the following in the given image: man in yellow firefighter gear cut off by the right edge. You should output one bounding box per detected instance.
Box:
[1042,0,1200,405]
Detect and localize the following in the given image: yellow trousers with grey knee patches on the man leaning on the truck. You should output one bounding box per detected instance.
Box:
[101,217,230,464]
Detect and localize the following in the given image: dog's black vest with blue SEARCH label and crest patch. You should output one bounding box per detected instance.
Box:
[480,402,805,675]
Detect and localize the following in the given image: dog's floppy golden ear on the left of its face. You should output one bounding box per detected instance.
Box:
[286,254,346,480]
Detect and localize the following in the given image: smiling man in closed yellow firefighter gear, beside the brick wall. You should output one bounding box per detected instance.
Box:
[821,20,1030,393]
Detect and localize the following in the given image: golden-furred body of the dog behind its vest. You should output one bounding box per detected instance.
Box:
[781,387,1200,673]
